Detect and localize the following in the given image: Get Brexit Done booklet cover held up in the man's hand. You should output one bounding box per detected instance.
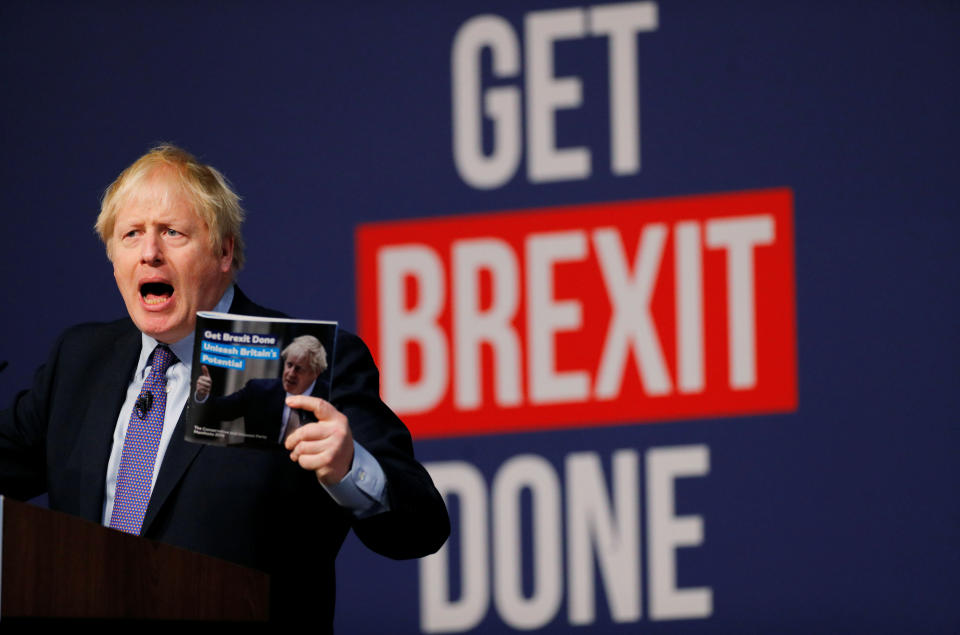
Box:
[185,311,337,448]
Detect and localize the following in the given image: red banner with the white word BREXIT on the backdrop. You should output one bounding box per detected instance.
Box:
[357,189,797,438]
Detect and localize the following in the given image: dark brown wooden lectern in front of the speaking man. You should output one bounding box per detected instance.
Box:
[0,497,270,624]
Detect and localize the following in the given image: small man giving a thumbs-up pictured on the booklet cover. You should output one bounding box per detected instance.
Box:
[194,335,329,447]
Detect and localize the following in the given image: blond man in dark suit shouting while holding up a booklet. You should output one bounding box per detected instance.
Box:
[0,146,449,631]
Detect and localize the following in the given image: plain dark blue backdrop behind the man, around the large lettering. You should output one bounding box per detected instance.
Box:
[0,0,960,633]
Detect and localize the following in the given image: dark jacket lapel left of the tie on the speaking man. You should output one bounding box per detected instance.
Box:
[77,325,140,523]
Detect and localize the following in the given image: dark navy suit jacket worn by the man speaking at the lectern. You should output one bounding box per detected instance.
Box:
[0,289,450,630]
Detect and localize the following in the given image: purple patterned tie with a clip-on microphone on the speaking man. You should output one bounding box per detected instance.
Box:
[110,344,178,534]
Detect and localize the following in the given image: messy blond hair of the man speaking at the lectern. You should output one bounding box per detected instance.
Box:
[94,144,245,271]
